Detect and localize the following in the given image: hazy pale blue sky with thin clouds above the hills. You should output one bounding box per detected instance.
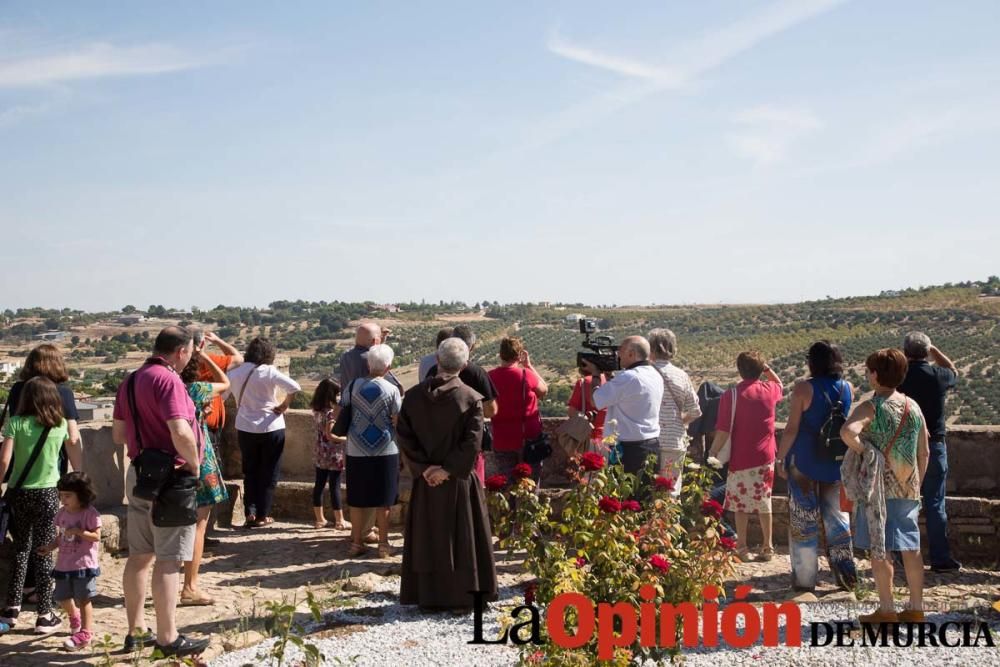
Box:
[0,0,1000,309]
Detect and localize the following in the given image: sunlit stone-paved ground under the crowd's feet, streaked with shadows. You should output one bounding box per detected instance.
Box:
[0,523,1000,665]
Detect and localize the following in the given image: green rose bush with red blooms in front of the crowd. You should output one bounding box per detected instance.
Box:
[488,455,735,665]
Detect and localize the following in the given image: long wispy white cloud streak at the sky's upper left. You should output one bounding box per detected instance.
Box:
[0,43,211,88]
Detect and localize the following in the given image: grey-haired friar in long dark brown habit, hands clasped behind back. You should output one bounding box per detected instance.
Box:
[396,338,497,611]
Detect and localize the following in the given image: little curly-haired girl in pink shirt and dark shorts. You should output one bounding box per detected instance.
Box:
[39,472,101,651]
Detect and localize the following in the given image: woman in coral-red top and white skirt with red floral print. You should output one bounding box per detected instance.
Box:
[711,352,784,562]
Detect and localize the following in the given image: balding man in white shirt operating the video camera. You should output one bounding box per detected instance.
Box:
[580,336,663,473]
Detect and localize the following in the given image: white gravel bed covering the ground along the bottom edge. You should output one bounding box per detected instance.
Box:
[211,577,1000,667]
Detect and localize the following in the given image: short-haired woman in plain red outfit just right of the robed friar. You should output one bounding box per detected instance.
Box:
[489,338,549,475]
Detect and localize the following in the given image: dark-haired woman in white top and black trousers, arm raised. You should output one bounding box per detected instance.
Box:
[228,337,302,528]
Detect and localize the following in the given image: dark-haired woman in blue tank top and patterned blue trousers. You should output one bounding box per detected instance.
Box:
[777,340,858,591]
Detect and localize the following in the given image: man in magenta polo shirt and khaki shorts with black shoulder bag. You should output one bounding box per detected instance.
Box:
[111,327,208,656]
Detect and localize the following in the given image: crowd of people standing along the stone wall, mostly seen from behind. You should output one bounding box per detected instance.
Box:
[0,323,960,656]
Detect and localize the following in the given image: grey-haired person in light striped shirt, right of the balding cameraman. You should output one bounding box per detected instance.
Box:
[648,329,701,496]
